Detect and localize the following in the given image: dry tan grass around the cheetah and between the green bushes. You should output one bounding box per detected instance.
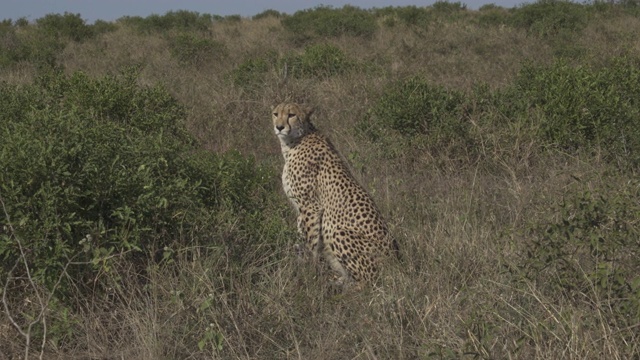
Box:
[0,6,640,359]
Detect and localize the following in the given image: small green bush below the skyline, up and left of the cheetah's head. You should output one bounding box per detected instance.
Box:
[169,33,227,66]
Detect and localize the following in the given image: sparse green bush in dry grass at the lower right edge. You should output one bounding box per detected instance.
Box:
[521,181,640,328]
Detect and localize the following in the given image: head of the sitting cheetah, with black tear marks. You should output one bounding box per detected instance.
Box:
[272,103,314,144]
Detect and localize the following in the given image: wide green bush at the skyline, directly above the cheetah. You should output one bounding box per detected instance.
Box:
[282,5,378,42]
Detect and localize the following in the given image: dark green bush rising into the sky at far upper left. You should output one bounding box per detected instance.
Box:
[36,13,95,42]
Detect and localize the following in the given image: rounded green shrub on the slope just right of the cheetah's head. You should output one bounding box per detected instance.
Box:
[355,76,477,165]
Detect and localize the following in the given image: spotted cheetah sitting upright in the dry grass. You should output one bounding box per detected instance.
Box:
[272,103,398,284]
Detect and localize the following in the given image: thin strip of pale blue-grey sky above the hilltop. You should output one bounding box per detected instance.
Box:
[0,0,535,24]
